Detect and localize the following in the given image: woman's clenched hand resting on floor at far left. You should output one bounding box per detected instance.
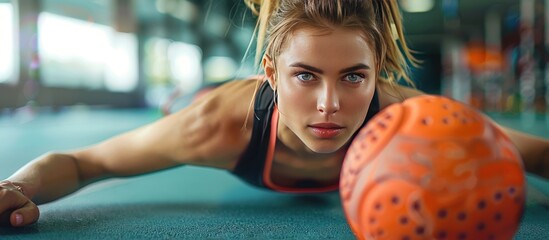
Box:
[0,180,40,227]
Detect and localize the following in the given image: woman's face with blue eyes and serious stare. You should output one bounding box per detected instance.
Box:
[266,28,376,153]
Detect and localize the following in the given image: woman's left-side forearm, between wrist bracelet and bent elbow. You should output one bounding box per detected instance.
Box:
[9,153,97,204]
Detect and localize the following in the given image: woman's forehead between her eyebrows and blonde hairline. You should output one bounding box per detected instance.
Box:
[279,28,374,67]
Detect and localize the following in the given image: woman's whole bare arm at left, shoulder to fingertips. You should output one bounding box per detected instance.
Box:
[0,79,255,226]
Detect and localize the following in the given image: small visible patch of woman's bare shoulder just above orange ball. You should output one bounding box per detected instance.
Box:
[377,81,425,109]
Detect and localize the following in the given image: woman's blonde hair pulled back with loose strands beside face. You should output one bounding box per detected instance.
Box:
[244,0,419,86]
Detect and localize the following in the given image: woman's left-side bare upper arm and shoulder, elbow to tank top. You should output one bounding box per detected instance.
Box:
[71,80,260,180]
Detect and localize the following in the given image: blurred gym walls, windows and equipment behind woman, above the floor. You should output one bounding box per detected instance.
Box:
[0,0,549,118]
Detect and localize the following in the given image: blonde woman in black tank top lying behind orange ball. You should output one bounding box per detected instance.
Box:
[0,0,549,226]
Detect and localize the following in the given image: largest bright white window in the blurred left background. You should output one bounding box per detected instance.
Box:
[38,12,138,92]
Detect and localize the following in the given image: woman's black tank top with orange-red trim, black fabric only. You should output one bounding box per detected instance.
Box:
[232,81,379,191]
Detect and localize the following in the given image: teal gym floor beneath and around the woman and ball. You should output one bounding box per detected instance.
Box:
[0,108,549,239]
